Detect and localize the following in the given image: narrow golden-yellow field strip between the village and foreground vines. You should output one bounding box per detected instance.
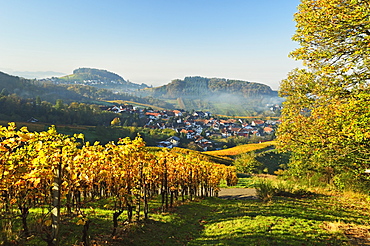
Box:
[207,141,276,156]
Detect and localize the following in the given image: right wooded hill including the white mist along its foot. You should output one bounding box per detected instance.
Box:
[138,76,282,116]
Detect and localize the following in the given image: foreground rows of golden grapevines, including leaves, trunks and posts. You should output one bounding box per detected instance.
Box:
[0,123,237,245]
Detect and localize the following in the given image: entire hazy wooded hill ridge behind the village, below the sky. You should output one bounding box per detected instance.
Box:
[0,68,282,116]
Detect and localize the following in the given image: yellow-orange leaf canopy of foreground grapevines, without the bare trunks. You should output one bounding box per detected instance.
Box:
[0,123,236,210]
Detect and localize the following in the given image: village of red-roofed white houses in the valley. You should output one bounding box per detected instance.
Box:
[106,105,281,151]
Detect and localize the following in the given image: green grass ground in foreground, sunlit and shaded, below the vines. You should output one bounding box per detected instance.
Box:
[9,179,370,246]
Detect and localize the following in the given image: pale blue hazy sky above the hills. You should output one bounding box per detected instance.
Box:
[0,0,300,89]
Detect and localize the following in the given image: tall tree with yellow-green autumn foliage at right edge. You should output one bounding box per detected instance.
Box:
[278,0,370,188]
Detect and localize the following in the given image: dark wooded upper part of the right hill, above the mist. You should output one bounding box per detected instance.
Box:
[141,76,277,98]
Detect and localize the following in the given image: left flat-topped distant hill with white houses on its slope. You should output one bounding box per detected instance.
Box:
[51,68,148,92]
